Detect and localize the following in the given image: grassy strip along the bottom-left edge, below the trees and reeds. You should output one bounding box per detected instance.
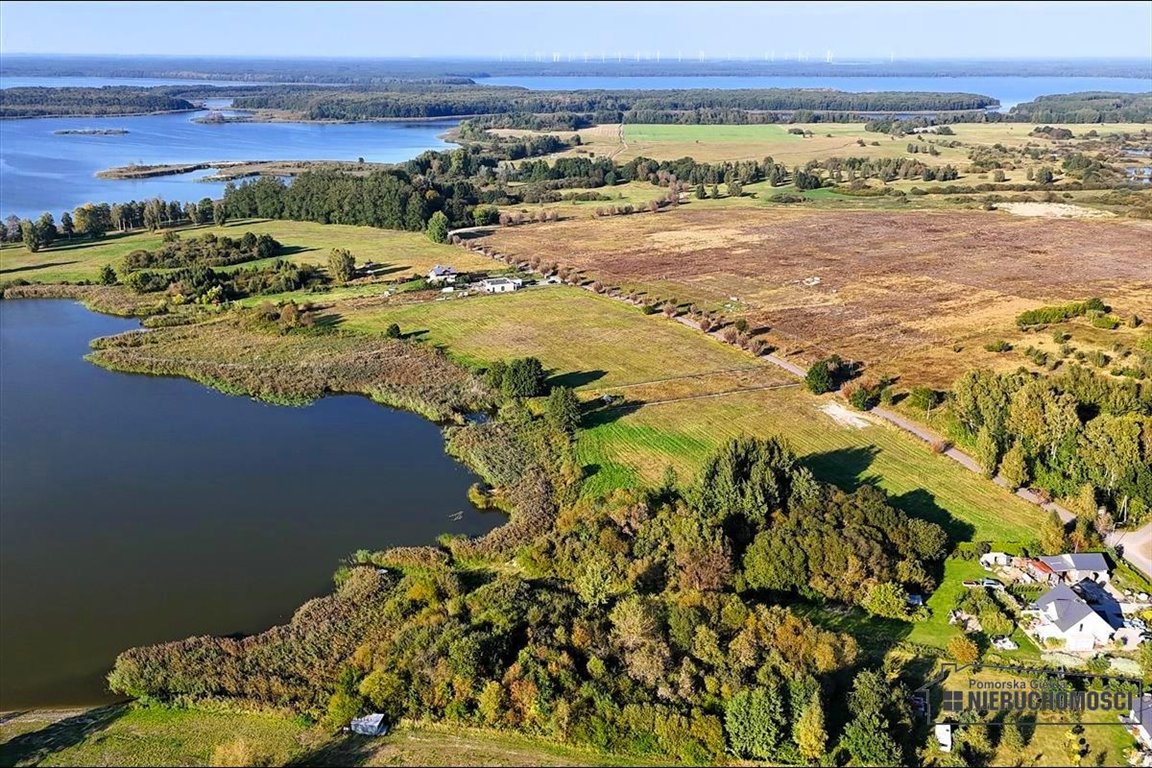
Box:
[0,707,652,766]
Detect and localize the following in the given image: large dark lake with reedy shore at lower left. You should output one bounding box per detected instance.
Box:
[0,299,503,710]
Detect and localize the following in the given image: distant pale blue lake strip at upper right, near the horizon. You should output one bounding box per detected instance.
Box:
[476,76,1152,109]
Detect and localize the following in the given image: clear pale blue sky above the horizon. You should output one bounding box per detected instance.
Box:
[0,0,1152,59]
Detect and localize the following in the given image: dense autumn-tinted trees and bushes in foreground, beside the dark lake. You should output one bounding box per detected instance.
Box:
[109,432,946,765]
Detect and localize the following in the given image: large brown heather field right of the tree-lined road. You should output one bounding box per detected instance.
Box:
[485,206,1152,386]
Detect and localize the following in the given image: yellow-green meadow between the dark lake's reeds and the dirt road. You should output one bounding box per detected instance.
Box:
[340,287,1041,540]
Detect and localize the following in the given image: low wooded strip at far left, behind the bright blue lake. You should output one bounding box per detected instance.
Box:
[0,86,195,117]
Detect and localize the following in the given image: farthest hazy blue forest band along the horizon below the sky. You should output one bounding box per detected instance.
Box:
[0,55,1149,83]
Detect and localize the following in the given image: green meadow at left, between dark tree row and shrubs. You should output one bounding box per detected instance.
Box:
[0,220,492,282]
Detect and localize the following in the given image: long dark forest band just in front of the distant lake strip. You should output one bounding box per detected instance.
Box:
[9,78,1152,123]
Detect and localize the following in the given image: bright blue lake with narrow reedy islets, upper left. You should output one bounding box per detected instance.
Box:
[0,113,457,221]
